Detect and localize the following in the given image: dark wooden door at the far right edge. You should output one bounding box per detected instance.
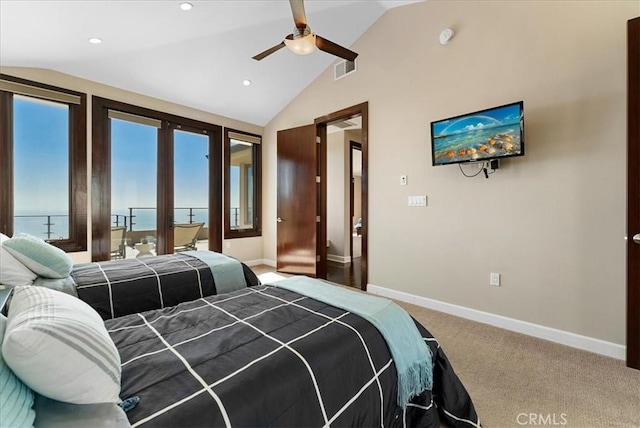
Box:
[627,18,640,369]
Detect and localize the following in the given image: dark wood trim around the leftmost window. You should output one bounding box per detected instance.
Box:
[0,74,87,253]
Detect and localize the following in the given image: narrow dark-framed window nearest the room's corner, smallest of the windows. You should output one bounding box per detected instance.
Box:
[224,129,262,239]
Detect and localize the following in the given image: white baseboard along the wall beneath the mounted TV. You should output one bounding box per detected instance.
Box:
[367,284,627,360]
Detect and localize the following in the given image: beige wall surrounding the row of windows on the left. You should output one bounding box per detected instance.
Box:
[0,67,262,263]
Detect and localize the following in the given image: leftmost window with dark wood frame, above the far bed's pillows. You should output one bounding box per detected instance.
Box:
[0,75,87,252]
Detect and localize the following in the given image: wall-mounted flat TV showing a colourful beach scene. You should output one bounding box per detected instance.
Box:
[431,101,524,166]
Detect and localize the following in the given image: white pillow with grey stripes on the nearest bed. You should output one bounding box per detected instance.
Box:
[2,287,121,404]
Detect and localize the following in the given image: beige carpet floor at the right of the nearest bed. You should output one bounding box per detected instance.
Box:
[252,266,640,428]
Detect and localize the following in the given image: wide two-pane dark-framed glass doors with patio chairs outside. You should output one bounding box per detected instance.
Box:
[91,96,223,261]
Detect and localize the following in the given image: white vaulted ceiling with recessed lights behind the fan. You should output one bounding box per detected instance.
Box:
[0,0,422,125]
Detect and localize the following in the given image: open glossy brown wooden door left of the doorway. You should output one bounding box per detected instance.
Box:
[276,125,319,277]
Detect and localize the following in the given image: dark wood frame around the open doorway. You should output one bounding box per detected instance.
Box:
[314,102,369,291]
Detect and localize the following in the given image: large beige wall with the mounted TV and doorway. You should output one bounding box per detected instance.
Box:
[263,0,640,344]
